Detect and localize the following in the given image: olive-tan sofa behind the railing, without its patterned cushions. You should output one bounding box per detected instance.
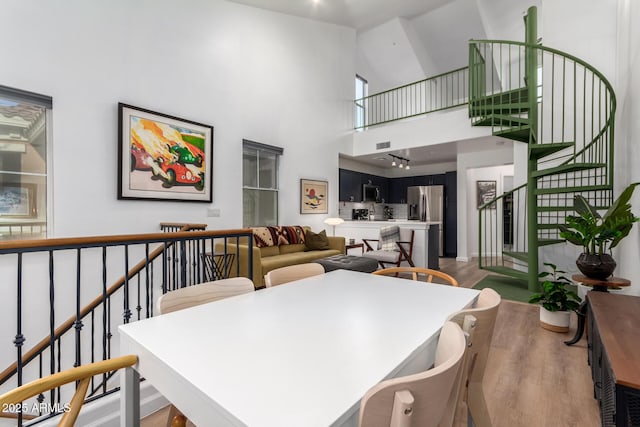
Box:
[216,227,345,288]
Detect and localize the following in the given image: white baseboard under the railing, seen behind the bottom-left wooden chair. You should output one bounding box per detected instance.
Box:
[38,382,169,427]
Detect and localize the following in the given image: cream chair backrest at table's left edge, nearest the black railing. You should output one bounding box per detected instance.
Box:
[158,277,255,314]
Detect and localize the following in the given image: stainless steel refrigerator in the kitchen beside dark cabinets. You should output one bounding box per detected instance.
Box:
[407,185,444,256]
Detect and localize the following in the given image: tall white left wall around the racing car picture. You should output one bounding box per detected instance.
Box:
[0,0,355,236]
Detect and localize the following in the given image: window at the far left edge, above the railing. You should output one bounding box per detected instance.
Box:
[0,86,52,240]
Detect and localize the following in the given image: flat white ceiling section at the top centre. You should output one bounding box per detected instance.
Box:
[229,0,452,31]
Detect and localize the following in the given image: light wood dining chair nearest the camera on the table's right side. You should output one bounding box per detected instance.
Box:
[359,322,466,427]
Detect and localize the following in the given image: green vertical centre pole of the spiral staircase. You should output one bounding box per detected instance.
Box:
[524,6,539,291]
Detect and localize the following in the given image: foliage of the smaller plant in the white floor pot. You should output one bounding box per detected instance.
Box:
[529,262,582,311]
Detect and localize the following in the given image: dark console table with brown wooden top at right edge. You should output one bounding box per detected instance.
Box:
[586,292,640,427]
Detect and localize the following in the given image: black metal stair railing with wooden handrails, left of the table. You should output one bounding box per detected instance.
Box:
[0,224,253,425]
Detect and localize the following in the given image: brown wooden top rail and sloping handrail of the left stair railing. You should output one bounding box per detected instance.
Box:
[0,224,251,385]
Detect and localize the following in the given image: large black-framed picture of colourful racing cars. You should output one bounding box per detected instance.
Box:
[118,103,213,203]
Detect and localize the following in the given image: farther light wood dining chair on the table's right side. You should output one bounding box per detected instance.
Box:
[444,288,502,427]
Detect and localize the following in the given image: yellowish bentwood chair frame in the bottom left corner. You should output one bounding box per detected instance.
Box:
[0,355,138,427]
